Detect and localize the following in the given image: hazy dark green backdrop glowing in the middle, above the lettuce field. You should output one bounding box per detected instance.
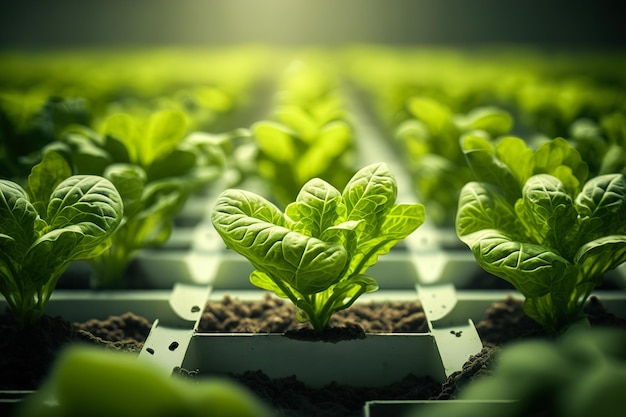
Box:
[0,0,626,48]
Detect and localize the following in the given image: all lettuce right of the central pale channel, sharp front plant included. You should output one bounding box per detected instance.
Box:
[351,48,626,332]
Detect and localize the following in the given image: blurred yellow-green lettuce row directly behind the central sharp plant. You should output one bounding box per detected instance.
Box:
[251,59,356,208]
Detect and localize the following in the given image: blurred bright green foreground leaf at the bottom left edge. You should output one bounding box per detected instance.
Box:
[15,346,273,417]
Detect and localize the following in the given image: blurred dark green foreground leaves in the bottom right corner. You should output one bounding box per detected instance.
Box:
[408,328,626,417]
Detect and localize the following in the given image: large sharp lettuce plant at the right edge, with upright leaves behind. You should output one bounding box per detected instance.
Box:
[456,136,626,332]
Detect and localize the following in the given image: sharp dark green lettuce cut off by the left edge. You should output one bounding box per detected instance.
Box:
[0,152,124,326]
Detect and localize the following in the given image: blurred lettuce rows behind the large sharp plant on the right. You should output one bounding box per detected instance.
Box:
[349,47,626,226]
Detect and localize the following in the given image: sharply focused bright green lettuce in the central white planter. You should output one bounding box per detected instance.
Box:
[211,163,425,332]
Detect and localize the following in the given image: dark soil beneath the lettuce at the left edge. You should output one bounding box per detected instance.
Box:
[0,312,151,390]
